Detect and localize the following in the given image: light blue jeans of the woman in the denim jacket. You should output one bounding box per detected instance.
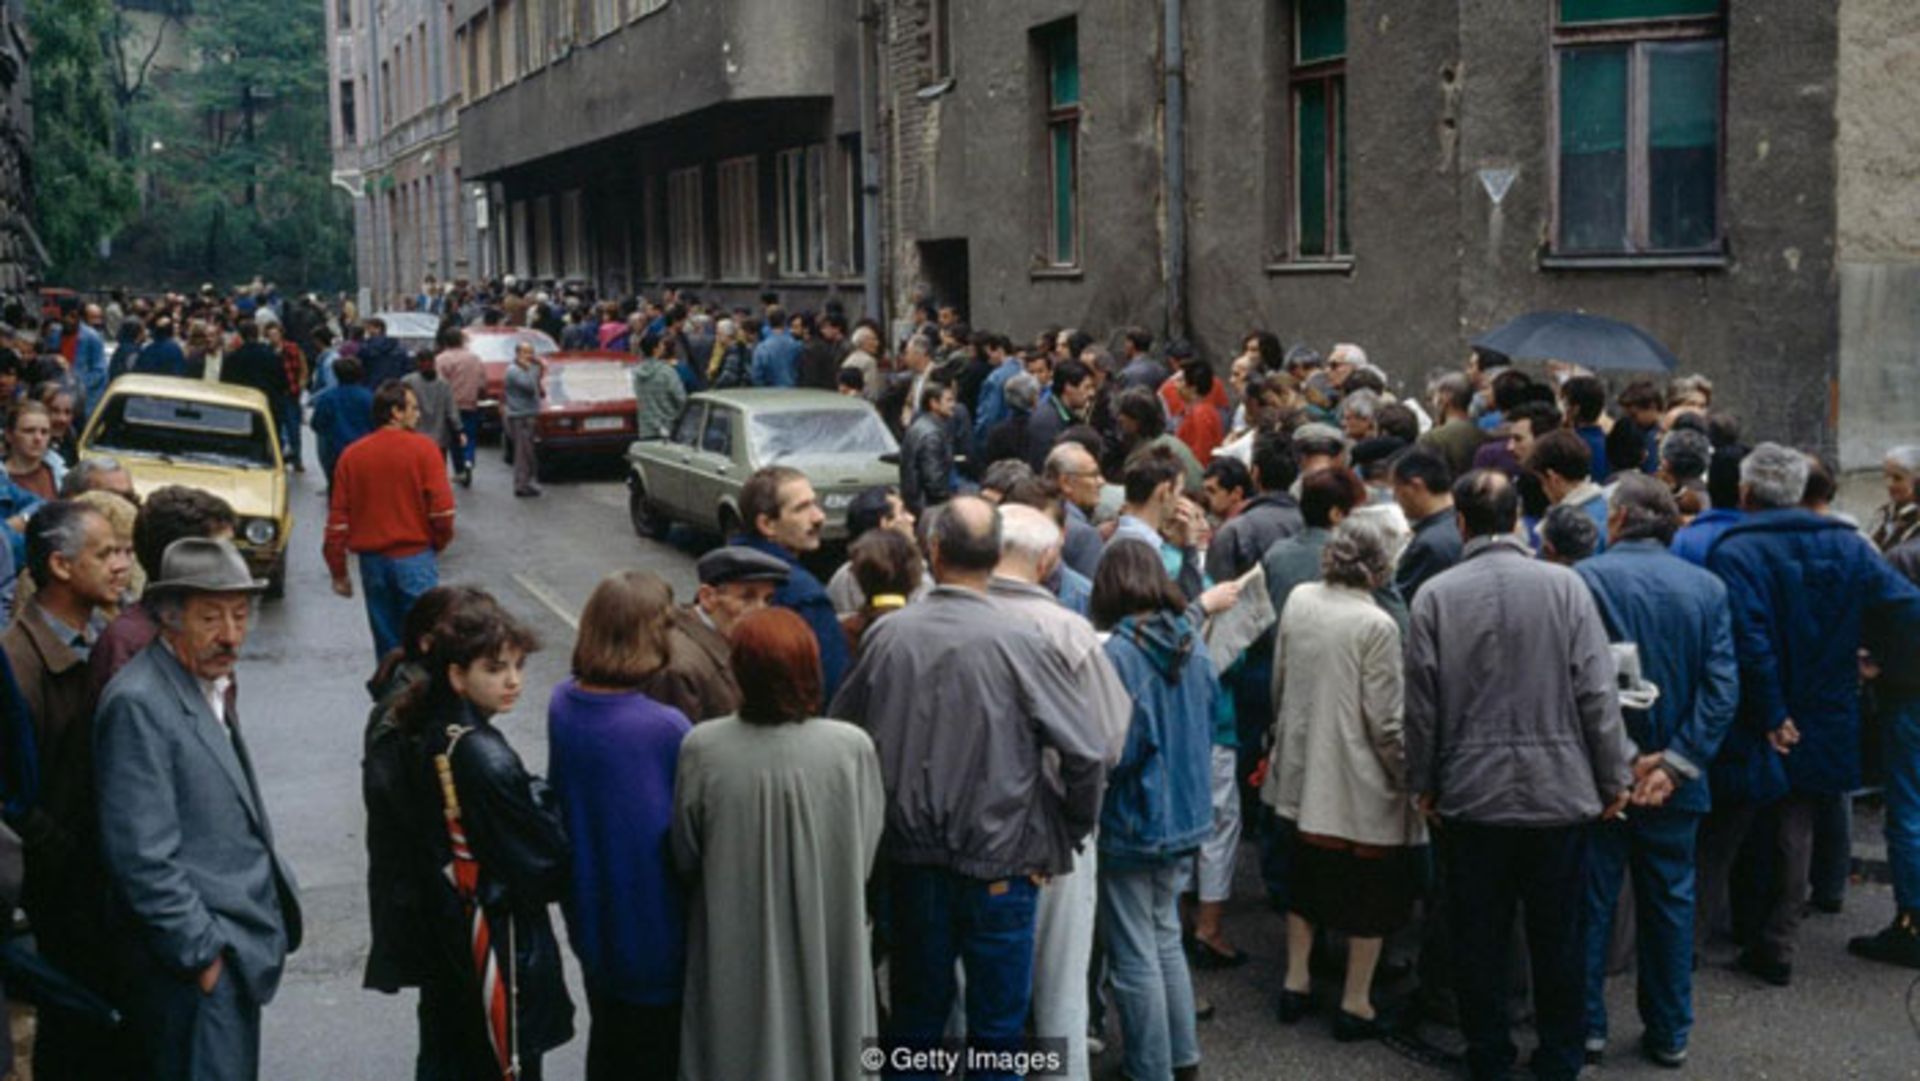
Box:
[1100,862,1200,1081]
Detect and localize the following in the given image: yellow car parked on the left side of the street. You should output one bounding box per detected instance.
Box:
[79,374,294,597]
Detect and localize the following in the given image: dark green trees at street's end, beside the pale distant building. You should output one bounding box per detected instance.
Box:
[103,0,353,292]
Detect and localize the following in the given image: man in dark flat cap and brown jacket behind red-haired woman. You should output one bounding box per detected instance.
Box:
[639,545,789,722]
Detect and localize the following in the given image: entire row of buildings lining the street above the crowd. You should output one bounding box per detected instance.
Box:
[328,0,1920,465]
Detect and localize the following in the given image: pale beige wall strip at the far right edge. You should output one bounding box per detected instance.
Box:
[1836,0,1920,468]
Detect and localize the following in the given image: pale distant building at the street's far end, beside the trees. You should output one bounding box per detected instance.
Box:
[324,0,492,311]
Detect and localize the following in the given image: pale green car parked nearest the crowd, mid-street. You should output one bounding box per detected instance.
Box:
[626,388,900,541]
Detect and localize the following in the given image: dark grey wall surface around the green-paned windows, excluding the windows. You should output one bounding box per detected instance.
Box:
[889,0,1858,445]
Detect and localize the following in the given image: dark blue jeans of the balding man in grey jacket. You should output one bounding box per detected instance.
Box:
[887,864,1039,1079]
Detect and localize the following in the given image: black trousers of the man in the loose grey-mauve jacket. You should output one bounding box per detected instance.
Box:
[1438,820,1588,1081]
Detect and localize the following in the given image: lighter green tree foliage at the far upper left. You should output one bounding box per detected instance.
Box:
[27,0,138,282]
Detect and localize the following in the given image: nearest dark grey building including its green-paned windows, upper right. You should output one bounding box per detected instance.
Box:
[887,0,1920,463]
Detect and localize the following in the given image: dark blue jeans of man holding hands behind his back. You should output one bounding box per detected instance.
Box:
[1586,810,1699,1048]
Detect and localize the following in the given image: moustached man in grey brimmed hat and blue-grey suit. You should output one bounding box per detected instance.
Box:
[94,538,301,1081]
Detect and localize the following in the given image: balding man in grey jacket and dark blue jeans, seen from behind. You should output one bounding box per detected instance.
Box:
[828,495,1110,1075]
